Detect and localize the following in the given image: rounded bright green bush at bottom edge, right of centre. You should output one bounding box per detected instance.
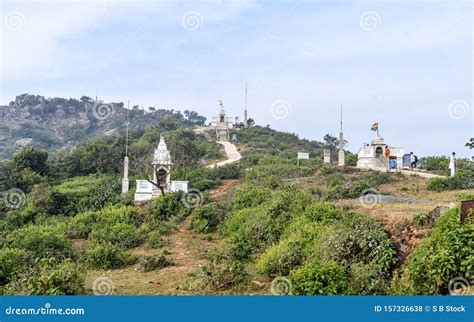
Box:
[289,262,348,295]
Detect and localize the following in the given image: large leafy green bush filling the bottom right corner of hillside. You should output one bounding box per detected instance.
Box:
[399,207,474,295]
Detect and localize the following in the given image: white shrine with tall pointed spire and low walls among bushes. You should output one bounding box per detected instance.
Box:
[135,136,188,202]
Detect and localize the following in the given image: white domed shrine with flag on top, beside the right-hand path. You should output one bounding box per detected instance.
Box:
[357,133,404,171]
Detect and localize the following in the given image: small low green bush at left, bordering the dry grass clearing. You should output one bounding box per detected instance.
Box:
[86,244,136,269]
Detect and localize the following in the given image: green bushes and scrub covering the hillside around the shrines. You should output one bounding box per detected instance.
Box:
[0,112,474,295]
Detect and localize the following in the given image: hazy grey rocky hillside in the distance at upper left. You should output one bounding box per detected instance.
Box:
[0,94,205,160]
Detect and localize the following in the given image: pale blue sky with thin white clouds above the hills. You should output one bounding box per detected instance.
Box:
[0,0,474,158]
